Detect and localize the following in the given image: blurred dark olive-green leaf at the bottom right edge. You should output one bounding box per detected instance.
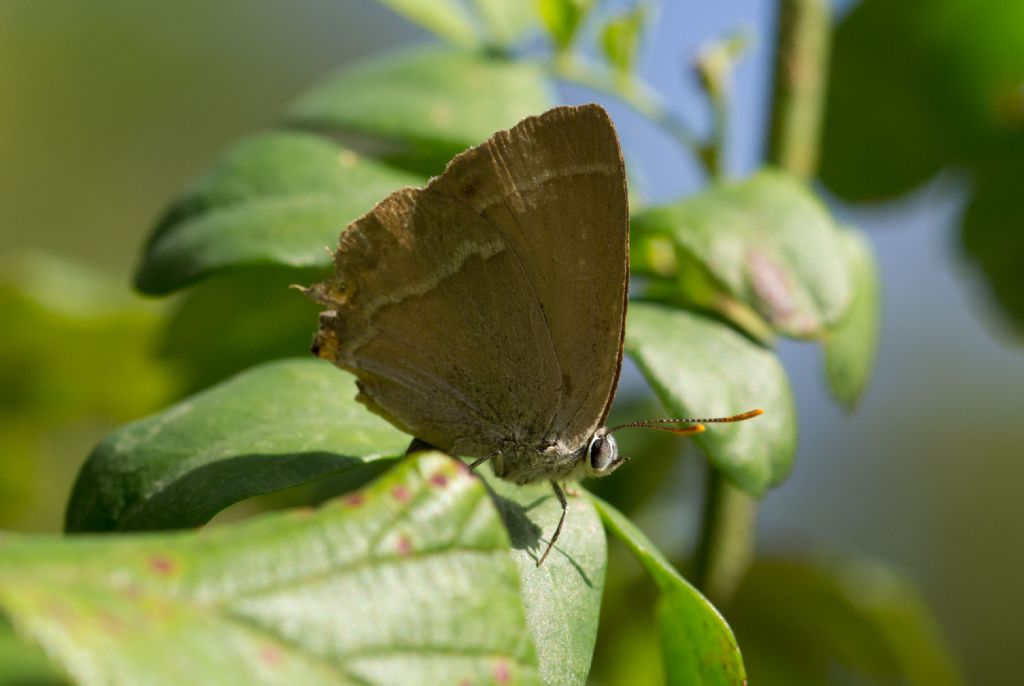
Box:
[730,558,961,686]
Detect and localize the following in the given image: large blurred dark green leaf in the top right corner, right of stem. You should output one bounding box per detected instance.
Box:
[821,0,1024,201]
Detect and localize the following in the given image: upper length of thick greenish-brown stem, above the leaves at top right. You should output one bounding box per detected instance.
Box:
[767,0,831,179]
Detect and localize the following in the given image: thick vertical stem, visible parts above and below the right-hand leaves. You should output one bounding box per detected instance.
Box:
[694,0,831,609]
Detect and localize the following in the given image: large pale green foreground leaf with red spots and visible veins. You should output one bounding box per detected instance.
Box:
[6,454,541,685]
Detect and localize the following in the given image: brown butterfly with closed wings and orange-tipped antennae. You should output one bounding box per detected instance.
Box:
[306,104,760,565]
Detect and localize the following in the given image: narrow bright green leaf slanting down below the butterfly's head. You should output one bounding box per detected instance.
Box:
[591,496,745,686]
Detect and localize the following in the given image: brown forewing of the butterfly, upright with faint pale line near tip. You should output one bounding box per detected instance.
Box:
[428,104,629,454]
